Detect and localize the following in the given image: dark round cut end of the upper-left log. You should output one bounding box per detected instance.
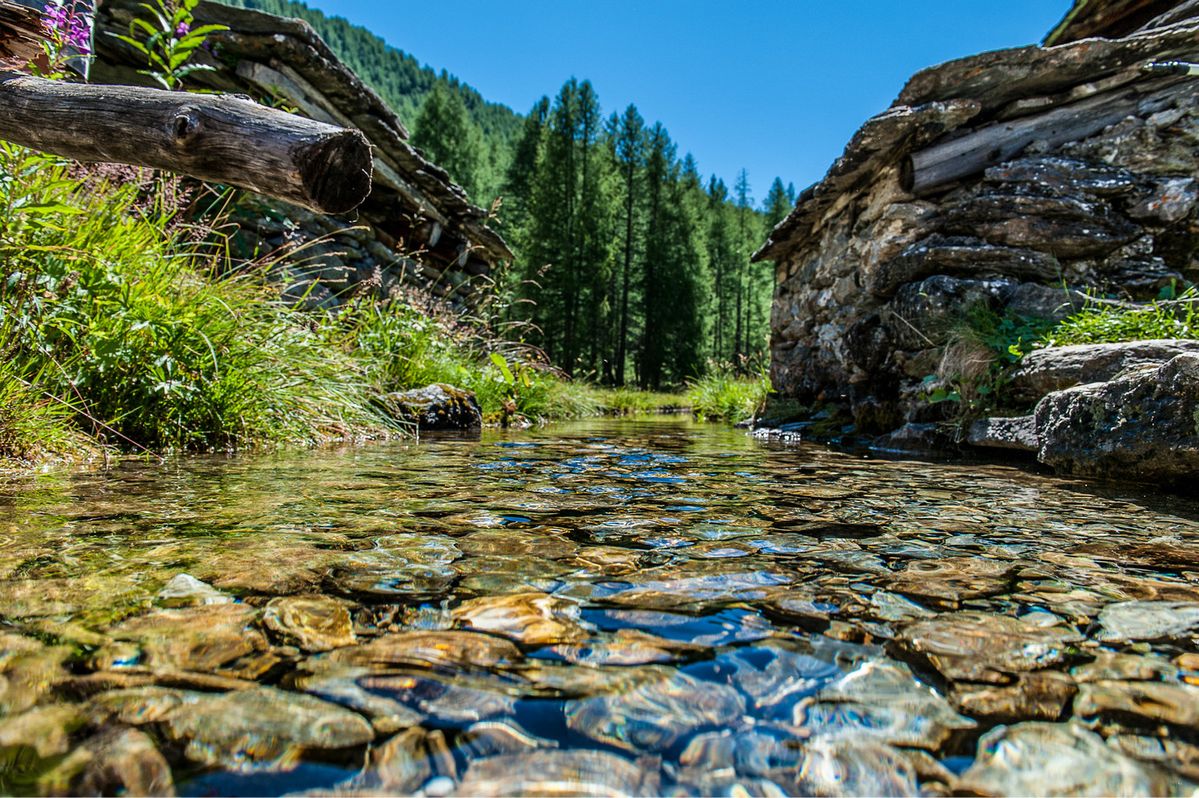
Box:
[295,129,374,213]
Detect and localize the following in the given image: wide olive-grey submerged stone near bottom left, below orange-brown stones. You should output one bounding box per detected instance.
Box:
[164,687,374,770]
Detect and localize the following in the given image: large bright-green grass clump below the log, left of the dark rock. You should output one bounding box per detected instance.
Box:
[0,145,387,449]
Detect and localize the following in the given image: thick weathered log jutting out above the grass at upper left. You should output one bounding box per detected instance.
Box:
[0,72,372,213]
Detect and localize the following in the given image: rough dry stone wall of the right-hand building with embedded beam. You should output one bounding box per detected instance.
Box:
[758,19,1199,433]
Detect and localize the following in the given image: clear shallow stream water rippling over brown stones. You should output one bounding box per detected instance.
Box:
[0,419,1199,796]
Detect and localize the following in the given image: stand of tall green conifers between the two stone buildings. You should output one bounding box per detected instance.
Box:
[501,79,794,391]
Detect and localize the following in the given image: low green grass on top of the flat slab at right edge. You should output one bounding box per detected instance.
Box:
[1043,289,1199,346]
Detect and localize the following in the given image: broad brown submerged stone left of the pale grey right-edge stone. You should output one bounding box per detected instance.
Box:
[896,611,1083,683]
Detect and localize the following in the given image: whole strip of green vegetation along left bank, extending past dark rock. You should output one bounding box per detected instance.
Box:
[0,145,596,460]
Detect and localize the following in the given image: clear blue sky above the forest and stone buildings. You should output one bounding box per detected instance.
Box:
[308,0,1071,200]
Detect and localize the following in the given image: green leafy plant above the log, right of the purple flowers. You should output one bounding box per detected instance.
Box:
[114,0,229,91]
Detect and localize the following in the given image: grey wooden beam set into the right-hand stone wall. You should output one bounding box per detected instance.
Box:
[900,84,1186,197]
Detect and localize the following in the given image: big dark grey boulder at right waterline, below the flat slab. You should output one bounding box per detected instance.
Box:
[1036,352,1199,483]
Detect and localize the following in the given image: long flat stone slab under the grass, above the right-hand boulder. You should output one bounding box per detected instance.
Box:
[1012,338,1199,400]
